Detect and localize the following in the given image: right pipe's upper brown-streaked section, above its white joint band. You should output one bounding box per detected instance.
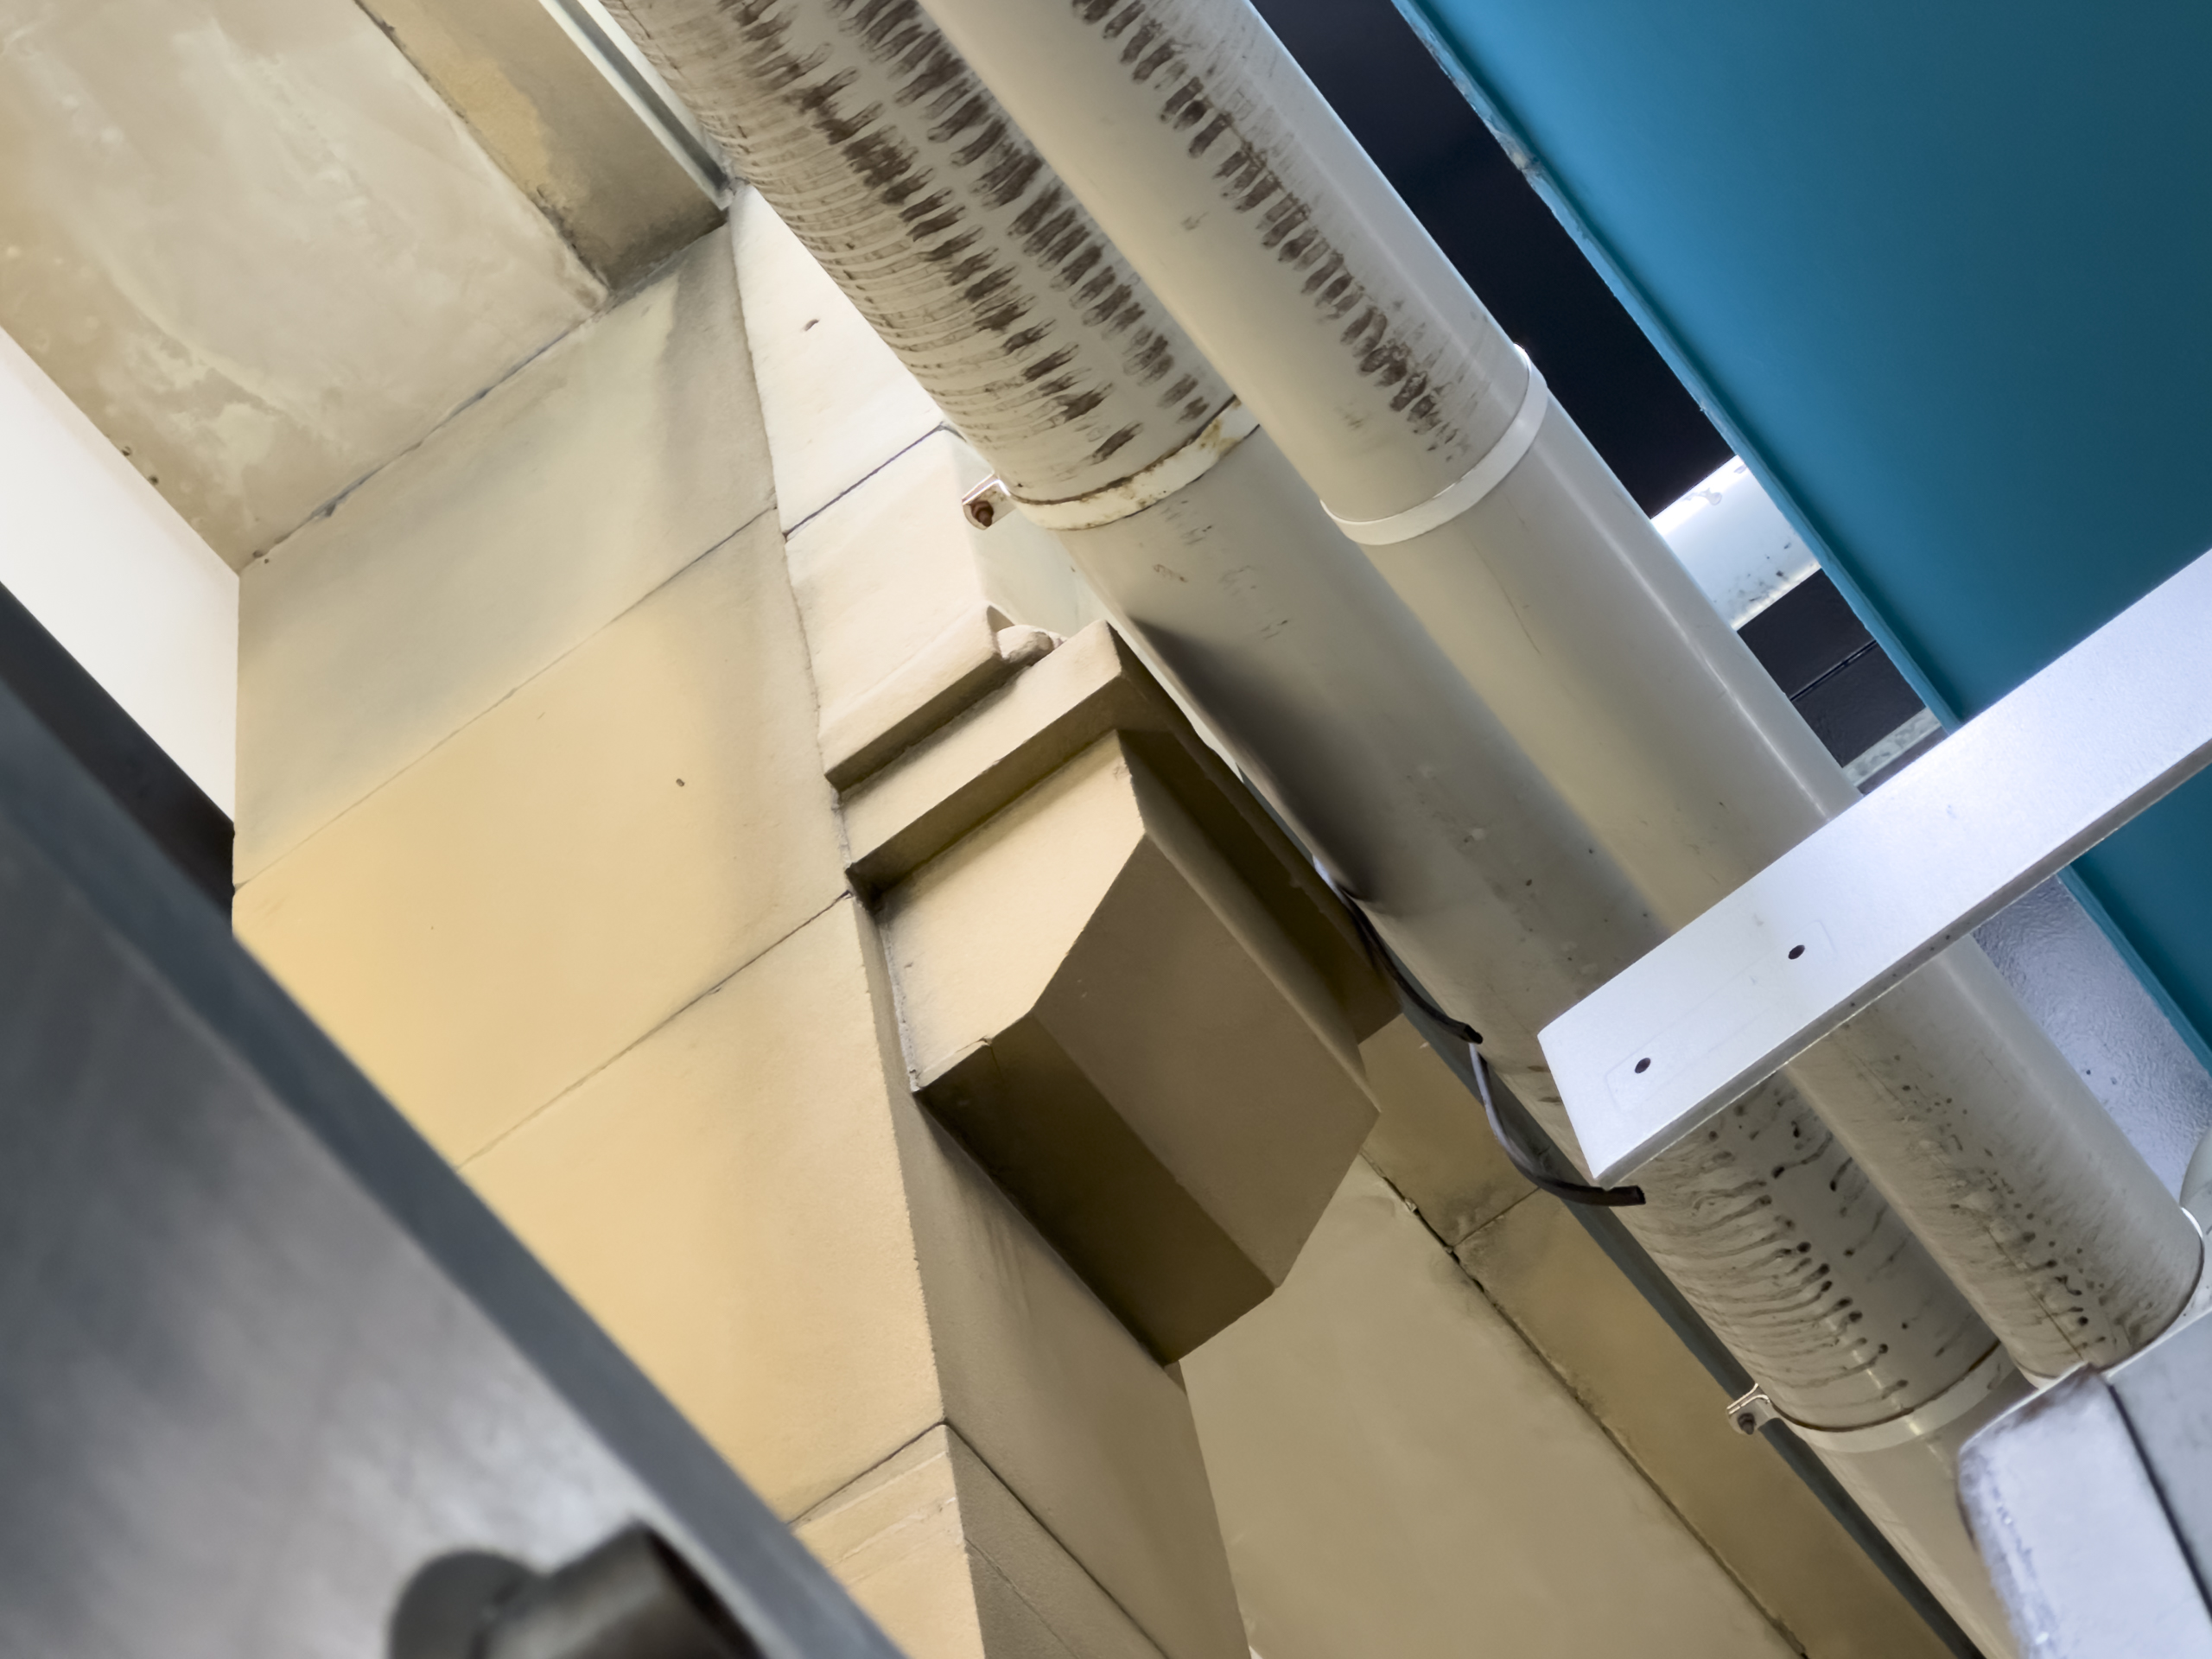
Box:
[906,0,1529,520]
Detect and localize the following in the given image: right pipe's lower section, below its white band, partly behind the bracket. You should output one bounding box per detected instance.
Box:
[1424,410,2201,1378]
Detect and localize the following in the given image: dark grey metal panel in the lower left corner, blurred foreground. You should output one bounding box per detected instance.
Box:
[0,677,896,1659]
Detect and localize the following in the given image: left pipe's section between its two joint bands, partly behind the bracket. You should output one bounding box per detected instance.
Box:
[1064,431,1995,1429]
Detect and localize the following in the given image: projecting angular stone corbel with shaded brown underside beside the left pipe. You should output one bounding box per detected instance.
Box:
[847,626,1389,1360]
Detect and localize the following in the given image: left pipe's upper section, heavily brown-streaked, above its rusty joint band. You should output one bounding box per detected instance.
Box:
[611,0,1230,500]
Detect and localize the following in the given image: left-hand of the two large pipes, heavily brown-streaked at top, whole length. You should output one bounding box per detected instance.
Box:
[601,0,2025,1637]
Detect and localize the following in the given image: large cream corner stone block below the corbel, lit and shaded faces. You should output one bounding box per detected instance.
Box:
[465,871,1241,1659]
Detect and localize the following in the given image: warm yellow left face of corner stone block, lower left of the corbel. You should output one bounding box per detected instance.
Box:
[462,900,944,1520]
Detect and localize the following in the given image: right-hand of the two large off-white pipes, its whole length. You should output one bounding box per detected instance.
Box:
[902,0,2201,1376]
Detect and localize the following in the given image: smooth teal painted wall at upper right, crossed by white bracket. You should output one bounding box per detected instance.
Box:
[1400,0,2212,1051]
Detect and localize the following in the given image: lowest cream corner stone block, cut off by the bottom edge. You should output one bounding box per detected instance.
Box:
[794,1427,1159,1659]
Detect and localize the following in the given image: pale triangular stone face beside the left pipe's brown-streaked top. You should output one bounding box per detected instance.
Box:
[730,186,944,529]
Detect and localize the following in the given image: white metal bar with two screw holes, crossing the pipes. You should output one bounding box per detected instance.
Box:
[1541,542,2212,1185]
